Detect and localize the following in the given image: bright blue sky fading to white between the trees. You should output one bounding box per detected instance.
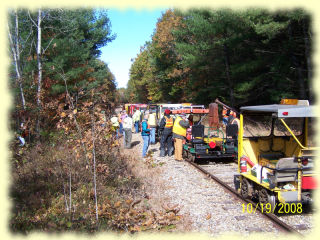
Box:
[100,9,165,88]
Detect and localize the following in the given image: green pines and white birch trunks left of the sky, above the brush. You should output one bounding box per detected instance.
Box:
[7,9,116,138]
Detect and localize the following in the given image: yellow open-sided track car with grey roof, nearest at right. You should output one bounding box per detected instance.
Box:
[234,100,317,206]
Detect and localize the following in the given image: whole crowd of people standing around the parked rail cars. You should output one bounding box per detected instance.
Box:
[111,108,239,161]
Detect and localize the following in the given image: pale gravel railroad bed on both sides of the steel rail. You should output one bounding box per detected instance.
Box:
[125,134,313,237]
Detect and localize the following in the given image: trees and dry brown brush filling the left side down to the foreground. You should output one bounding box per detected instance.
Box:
[7,9,125,233]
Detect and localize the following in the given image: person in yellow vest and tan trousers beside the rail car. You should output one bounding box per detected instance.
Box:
[172,113,189,161]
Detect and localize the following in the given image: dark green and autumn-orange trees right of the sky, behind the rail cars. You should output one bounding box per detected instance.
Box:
[125,8,314,107]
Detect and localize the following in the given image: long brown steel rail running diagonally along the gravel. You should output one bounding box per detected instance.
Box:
[185,160,304,237]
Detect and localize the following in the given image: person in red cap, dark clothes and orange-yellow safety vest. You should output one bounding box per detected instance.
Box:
[159,109,174,157]
